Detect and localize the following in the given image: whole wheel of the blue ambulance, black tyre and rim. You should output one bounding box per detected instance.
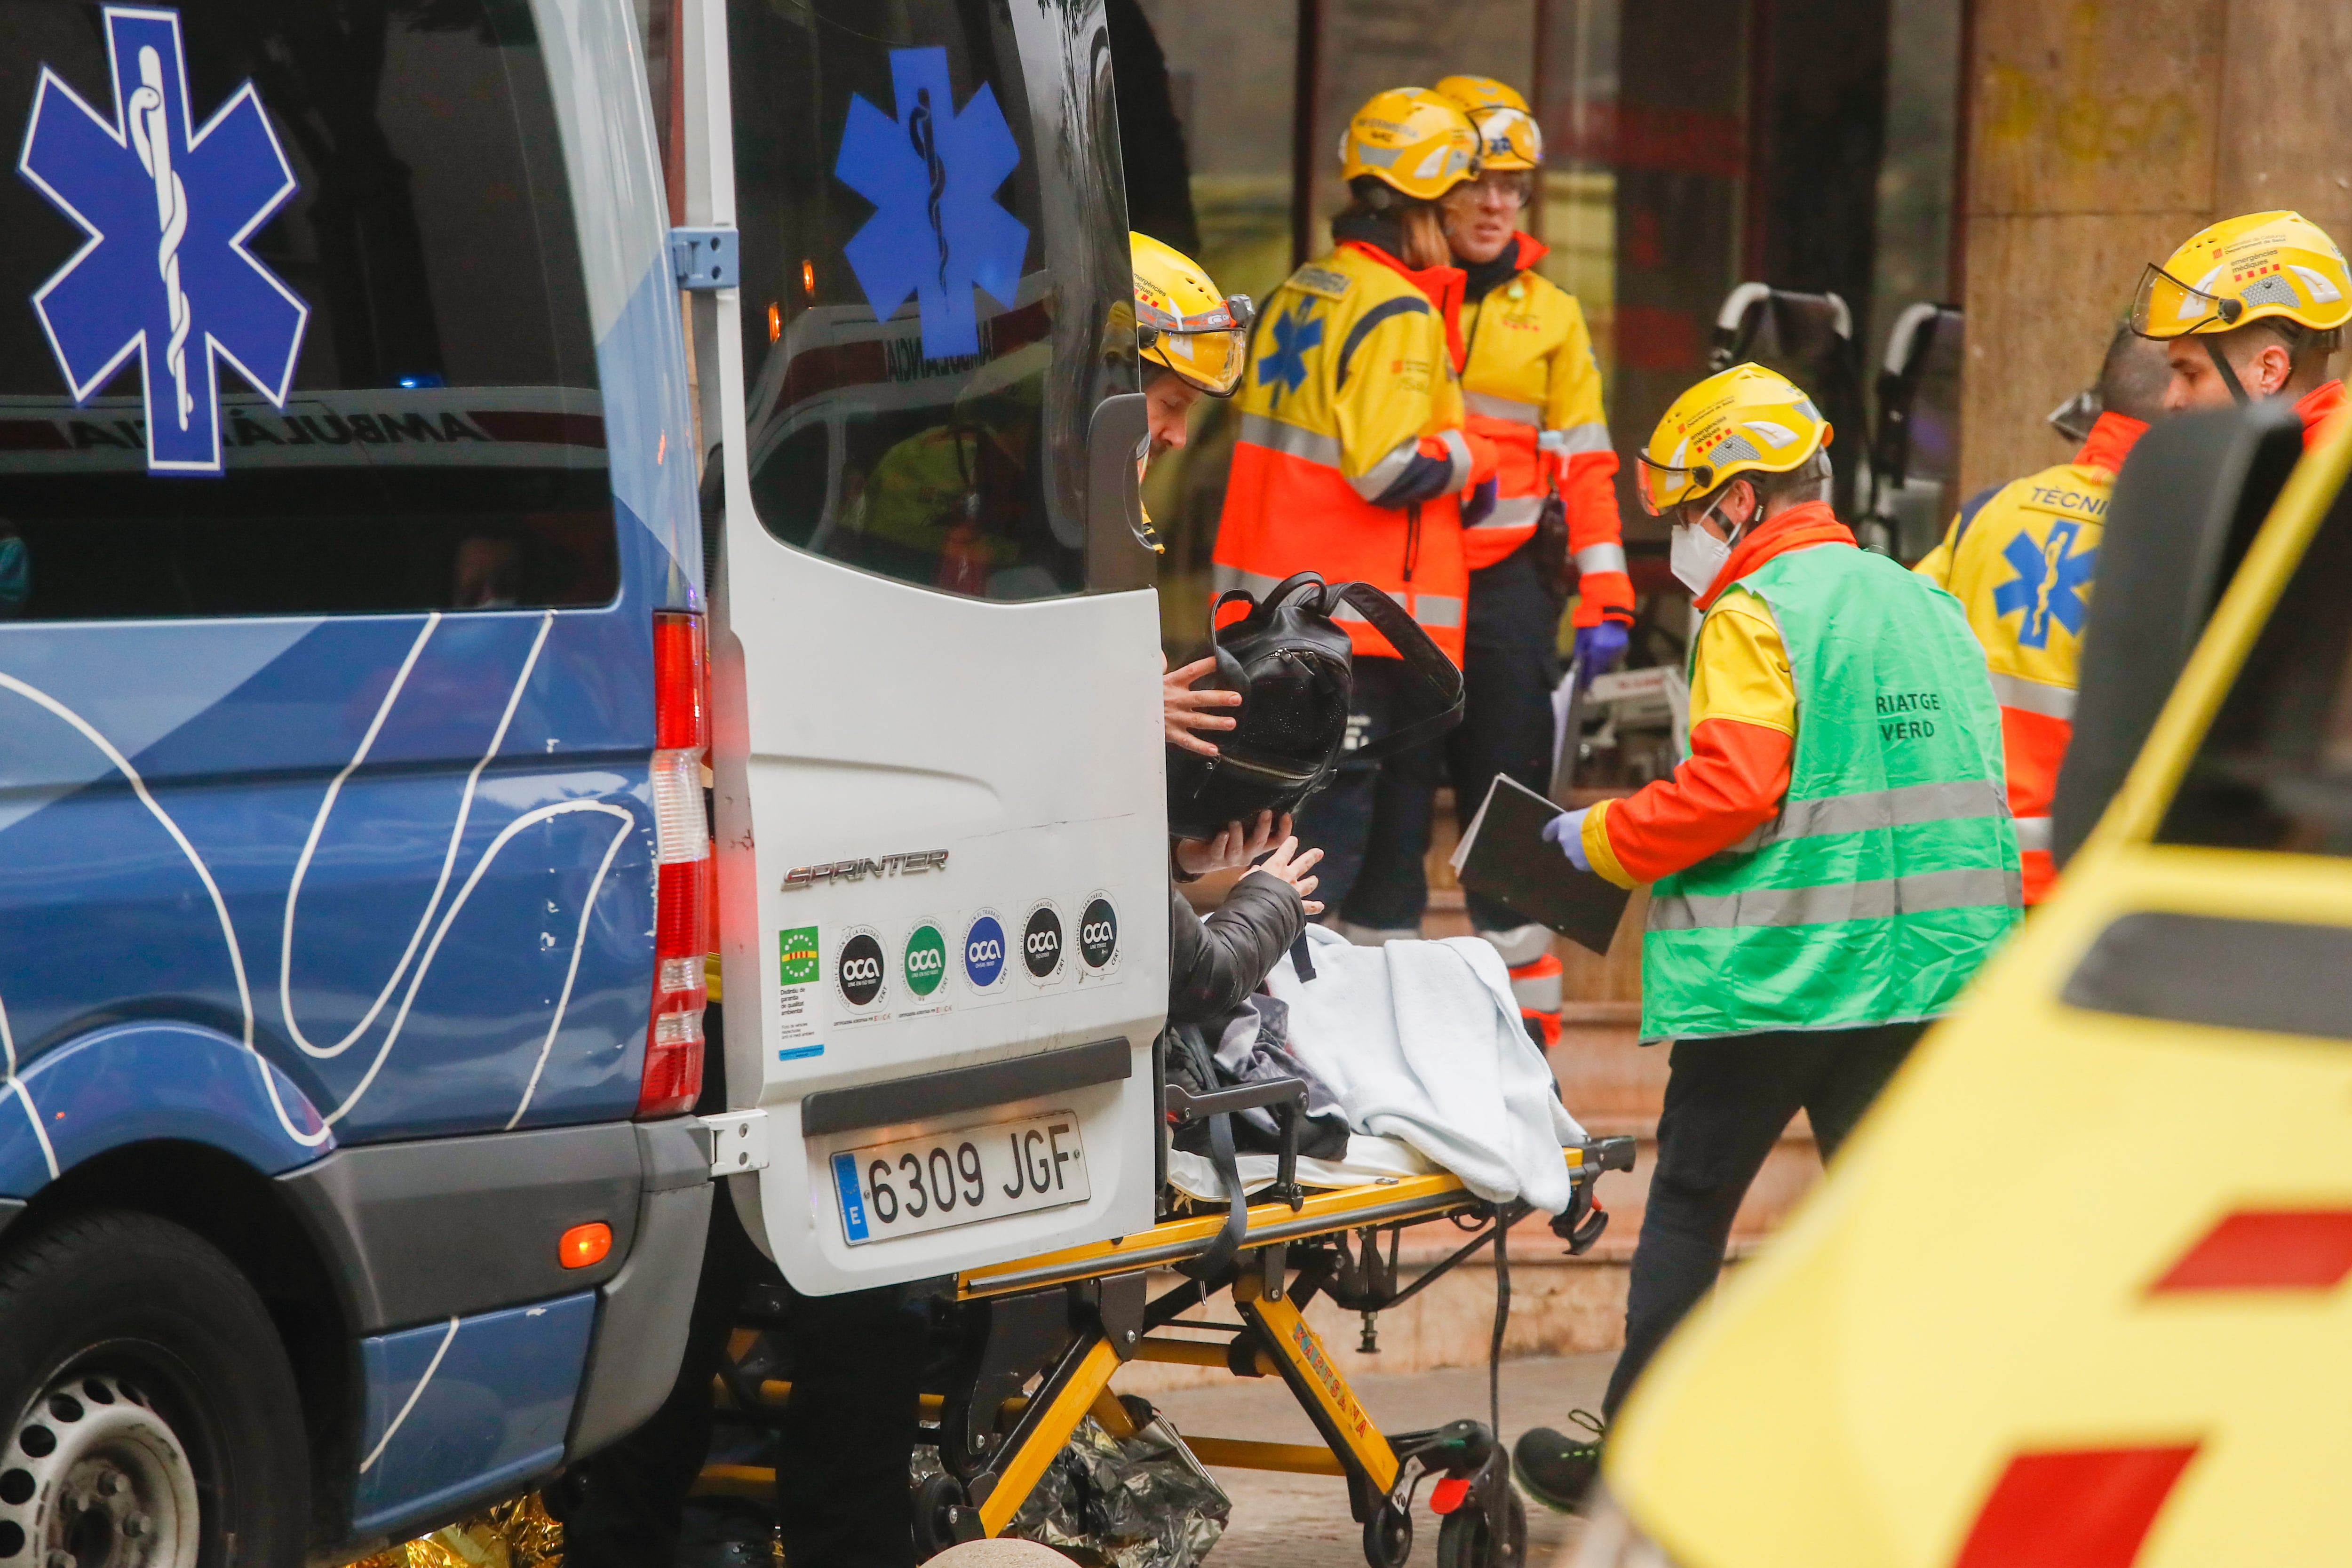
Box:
[0,1210,310,1568]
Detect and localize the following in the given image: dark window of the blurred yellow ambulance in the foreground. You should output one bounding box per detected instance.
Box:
[2157,489,2352,856]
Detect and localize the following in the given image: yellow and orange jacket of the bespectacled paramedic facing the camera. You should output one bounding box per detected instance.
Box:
[1463,235,1632,625]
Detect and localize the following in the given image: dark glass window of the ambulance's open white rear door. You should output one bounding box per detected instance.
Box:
[727,0,1134,599]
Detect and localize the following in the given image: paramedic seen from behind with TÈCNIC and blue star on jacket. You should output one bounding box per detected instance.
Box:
[1915,327,2171,905]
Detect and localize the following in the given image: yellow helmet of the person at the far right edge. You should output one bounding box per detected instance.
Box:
[2131,212,2352,339]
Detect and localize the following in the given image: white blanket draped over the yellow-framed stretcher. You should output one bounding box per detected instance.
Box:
[1268,926,1585,1213]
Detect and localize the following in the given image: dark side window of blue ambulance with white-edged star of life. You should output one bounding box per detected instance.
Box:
[0,0,619,621]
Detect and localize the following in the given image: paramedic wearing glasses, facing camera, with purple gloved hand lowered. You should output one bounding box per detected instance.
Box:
[1437,75,1632,1020]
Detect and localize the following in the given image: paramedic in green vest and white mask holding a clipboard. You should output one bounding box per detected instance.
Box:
[1515,365,2020,1507]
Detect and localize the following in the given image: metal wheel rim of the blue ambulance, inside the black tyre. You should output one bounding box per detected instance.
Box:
[0,1370,202,1568]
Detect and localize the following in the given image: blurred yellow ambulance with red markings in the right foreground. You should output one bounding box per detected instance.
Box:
[1571,406,2352,1568]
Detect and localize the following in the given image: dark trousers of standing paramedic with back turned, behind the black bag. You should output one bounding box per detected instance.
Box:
[1298,658,1444,926]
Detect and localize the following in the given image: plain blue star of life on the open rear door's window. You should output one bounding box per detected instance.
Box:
[833,49,1028,360]
